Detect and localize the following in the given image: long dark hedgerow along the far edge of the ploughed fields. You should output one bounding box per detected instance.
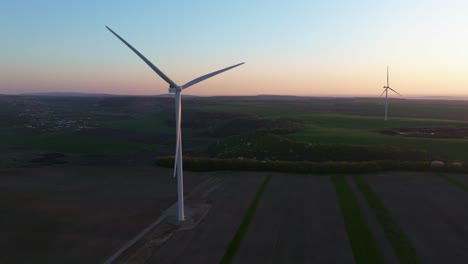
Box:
[155,157,438,174]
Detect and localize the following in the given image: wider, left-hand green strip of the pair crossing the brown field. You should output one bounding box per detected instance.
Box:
[331,176,384,264]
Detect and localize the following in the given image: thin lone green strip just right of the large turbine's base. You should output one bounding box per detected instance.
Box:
[220,175,271,264]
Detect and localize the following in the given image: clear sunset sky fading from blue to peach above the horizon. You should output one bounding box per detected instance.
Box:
[0,0,468,96]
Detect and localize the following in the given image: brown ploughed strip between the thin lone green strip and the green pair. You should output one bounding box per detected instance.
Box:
[232,173,354,264]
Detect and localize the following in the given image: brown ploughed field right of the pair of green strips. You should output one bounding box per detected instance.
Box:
[362,172,468,263]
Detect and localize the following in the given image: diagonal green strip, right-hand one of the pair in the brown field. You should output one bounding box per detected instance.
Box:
[355,176,422,264]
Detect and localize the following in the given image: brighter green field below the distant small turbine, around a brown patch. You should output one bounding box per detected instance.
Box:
[288,114,468,160]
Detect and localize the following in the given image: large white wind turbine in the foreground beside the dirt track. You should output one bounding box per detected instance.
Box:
[106,26,244,221]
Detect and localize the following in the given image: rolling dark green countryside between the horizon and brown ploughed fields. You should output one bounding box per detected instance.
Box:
[0,96,468,168]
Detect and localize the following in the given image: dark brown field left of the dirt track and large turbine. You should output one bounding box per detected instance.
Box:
[0,165,207,263]
